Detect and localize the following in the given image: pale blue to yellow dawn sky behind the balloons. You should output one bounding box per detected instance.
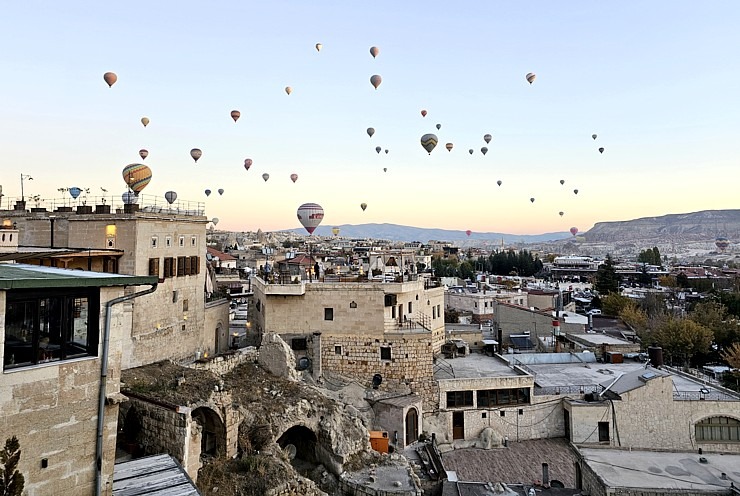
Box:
[0,0,740,234]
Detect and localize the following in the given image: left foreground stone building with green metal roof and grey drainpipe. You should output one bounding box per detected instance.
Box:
[0,264,157,496]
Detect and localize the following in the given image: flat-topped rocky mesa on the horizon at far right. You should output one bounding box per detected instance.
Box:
[583,210,740,243]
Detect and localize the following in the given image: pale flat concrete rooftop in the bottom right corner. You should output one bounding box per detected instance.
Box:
[579,448,740,493]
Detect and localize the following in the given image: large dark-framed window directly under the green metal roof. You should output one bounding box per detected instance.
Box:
[4,288,100,369]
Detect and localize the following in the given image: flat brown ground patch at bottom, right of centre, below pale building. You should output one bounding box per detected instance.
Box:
[442,438,576,487]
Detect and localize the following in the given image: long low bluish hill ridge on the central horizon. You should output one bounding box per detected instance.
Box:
[291,224,571,245]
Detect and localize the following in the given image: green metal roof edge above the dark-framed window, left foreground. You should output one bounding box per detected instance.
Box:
[0,263,158,290]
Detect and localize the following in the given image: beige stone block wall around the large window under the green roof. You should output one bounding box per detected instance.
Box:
[0,287,125,496]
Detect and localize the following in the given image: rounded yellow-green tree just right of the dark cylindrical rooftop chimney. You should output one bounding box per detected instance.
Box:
[652,317,713,365]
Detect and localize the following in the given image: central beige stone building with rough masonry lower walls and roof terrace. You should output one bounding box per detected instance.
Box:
[252,276,445,415]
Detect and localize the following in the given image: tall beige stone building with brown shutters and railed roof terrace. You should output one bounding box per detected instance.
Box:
[3,199,229,368]
